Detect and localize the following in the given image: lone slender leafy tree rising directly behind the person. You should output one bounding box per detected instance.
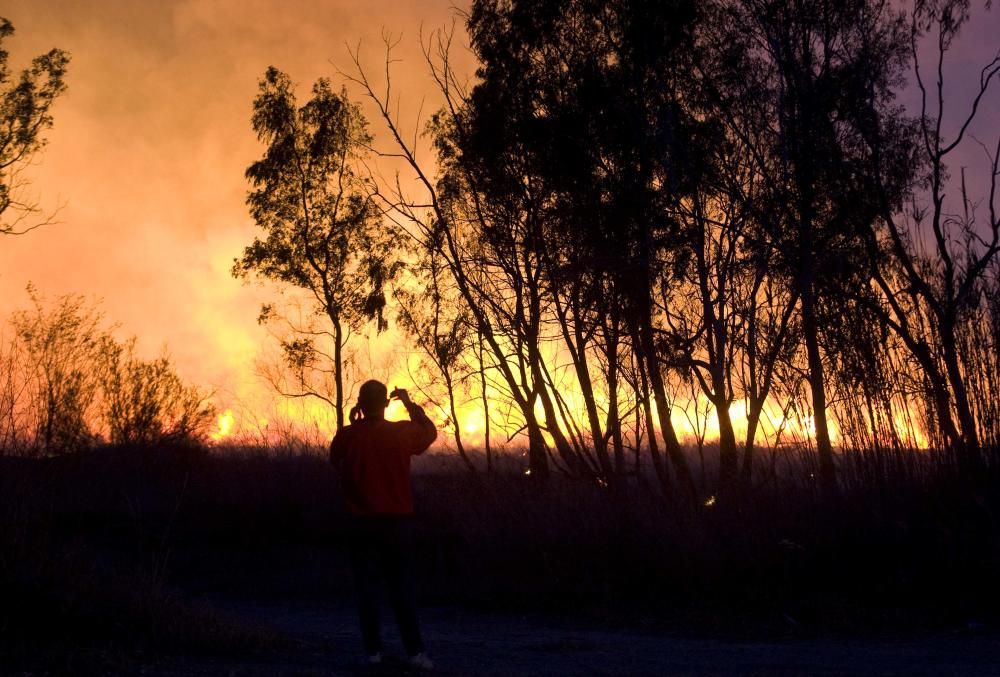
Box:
[233,67,400,429]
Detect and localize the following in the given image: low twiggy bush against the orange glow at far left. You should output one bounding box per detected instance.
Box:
[4,286,214,455]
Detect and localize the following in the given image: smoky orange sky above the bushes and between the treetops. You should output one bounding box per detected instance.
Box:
[0,0,1000,440]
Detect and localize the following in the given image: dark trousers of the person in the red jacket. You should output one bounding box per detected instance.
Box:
[351,515,424,656]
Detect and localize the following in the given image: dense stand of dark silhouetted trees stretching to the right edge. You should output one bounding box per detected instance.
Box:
[236,0,1000,495]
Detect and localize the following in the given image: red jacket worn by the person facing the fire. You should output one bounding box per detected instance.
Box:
[330,403,437,515]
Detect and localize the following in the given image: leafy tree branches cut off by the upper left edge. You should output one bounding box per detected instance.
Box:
[0,17,69,235]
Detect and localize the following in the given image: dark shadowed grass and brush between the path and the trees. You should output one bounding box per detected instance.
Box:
[0,438,1000,669]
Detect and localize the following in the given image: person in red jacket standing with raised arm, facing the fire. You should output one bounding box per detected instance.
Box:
[330,381,437,669]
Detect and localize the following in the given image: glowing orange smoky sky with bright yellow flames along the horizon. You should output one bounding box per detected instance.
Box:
[0,0,929,454]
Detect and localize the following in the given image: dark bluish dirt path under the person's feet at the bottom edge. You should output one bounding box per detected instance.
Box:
[143,603,1000,677]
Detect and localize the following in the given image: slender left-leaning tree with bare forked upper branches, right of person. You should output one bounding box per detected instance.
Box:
[347,32,578,478]
